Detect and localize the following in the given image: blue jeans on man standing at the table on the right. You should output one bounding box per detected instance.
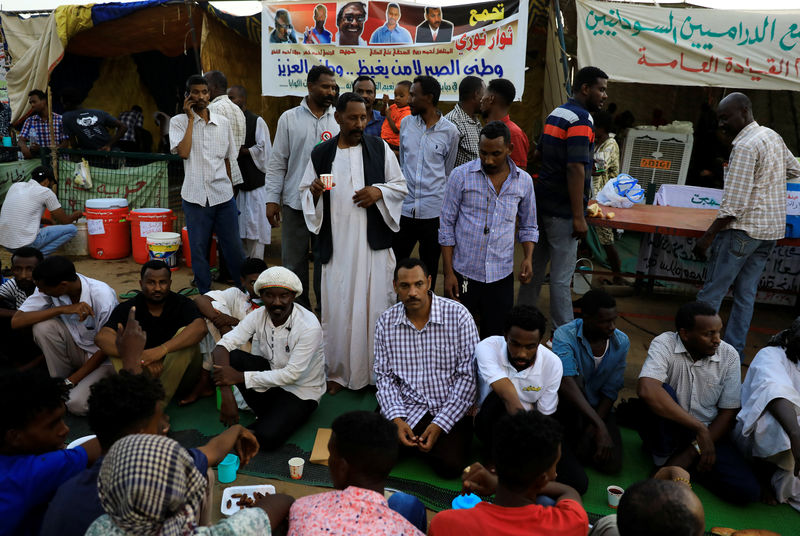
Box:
[697,229,775,360]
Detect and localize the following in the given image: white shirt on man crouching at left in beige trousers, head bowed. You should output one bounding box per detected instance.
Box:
[19,274,119,354]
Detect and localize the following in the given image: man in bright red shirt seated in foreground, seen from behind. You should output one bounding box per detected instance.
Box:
[428,411,589,536]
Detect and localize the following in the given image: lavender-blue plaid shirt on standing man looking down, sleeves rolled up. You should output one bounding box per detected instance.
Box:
[439,158,539,283]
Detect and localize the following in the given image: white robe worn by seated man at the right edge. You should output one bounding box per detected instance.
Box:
[734,346,800,510]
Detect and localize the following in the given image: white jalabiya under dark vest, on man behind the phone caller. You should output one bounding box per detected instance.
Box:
[236,117,272,259]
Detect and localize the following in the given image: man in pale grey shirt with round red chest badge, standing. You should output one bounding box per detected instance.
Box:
[266,65,339,309]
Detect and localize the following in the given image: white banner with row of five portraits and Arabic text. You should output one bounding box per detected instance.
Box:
[261,0,528,101]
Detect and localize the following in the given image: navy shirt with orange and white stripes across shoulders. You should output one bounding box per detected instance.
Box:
[536,99,594,218]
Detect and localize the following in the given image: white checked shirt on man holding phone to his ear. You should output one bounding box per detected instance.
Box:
[169,111,234,206]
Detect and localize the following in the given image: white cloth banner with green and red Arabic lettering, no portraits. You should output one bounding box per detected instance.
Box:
[577,0,800,91]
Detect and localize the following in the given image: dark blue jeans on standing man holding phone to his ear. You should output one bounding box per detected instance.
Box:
[182,198,244,294]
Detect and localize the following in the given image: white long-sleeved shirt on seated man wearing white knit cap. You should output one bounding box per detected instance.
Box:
[217,303,325,402]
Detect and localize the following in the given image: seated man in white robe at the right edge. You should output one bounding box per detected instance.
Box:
[734,317,800,510]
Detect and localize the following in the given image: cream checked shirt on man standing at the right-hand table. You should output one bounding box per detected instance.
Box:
[717,121,800,240]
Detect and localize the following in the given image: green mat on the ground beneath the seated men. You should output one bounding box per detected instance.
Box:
[68,390,800,536]
